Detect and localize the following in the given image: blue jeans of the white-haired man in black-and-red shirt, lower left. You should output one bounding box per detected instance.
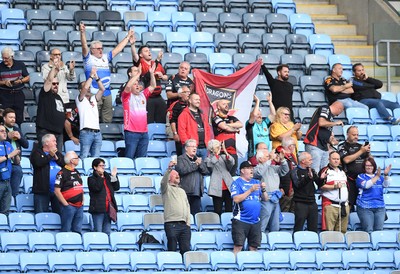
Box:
[61,205,83,233]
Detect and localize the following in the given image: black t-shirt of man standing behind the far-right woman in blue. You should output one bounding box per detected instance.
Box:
[339,142,369,180]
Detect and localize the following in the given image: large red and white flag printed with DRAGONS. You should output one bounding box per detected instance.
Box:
[192,61,261,157]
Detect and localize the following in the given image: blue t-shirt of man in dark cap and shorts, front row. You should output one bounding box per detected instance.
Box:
[231,177,261,224]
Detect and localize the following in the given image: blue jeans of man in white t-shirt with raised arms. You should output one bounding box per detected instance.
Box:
[79,129,102,159]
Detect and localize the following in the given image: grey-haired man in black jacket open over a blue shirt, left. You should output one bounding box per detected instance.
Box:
[29,134,65,214]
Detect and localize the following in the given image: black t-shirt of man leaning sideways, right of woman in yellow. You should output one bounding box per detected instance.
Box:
[304,106,333,151]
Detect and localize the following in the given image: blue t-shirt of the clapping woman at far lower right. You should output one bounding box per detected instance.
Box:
[356,173,385,208]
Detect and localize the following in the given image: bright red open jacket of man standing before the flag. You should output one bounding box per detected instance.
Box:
[178,107,210,146]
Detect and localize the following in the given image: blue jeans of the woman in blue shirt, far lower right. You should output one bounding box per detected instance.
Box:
[357,206,386,233]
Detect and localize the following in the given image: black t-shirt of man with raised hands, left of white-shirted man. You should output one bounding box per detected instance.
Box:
[36,88,65,134]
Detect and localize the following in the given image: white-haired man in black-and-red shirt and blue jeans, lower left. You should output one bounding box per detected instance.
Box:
[54,151,83,233]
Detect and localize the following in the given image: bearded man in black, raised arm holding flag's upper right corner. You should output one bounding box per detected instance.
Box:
[259,58,293,120]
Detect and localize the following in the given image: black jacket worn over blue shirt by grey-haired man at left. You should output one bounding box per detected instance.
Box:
[29,144,65,194]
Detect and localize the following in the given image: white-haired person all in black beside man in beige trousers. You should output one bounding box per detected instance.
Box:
[290,152,320,232]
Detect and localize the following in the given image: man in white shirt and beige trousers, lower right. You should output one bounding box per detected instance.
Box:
[318,151,350,234]
